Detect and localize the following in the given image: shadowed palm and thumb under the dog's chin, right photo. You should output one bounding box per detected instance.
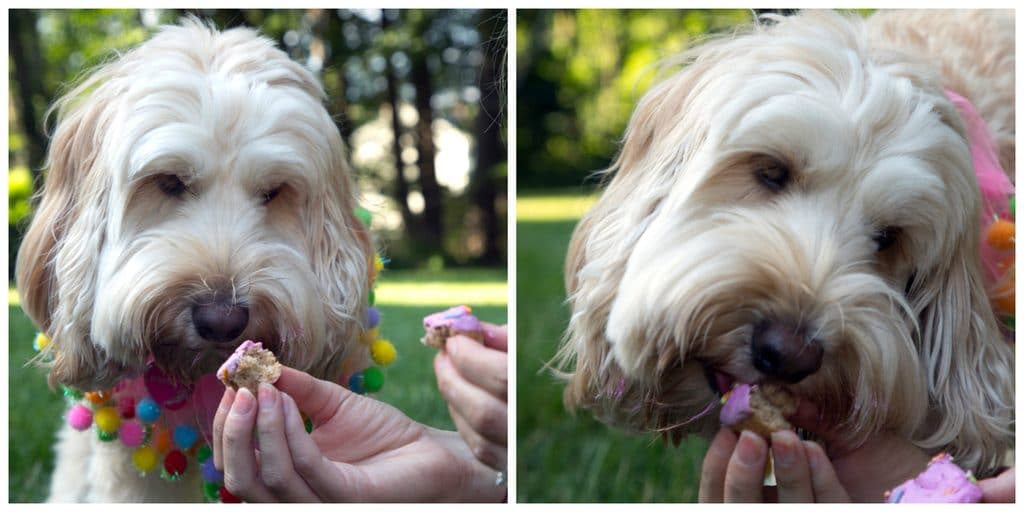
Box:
[791,401,932,503]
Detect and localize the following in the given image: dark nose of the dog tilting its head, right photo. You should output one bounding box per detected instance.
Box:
[751,321,824,383]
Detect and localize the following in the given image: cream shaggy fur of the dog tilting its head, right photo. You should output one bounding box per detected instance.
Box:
[557,11,1014,475]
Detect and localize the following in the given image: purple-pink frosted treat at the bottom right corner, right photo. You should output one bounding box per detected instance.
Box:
[885,454,981,503]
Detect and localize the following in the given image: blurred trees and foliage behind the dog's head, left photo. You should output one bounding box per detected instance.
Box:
[8,9,506,276]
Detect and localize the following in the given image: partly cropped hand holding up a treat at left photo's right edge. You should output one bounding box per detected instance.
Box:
[434,323,508,471]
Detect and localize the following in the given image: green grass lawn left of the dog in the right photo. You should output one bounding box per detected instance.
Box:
[516,194,707,503]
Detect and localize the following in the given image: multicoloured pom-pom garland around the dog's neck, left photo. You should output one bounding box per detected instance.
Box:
[33,208,397,503]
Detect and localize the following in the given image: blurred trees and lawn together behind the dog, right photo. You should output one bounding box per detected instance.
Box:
[515,9,755,503]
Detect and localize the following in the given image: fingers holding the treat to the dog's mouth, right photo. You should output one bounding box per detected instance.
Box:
[698,428,850,503]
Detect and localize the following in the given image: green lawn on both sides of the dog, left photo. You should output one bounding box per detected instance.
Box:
[8,269,507,503]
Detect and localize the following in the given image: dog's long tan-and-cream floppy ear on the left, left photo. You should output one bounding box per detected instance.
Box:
[16,70,115,389]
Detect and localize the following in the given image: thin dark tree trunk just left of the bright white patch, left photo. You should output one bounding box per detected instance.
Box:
[412,51,443,245]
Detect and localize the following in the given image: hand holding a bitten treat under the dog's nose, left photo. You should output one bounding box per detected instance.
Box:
[213,368,505,502]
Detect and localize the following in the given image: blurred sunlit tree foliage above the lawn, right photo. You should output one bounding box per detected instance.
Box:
[516,9,753,188]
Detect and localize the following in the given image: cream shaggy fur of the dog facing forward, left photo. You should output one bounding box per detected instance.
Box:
[17,19,373,501]
